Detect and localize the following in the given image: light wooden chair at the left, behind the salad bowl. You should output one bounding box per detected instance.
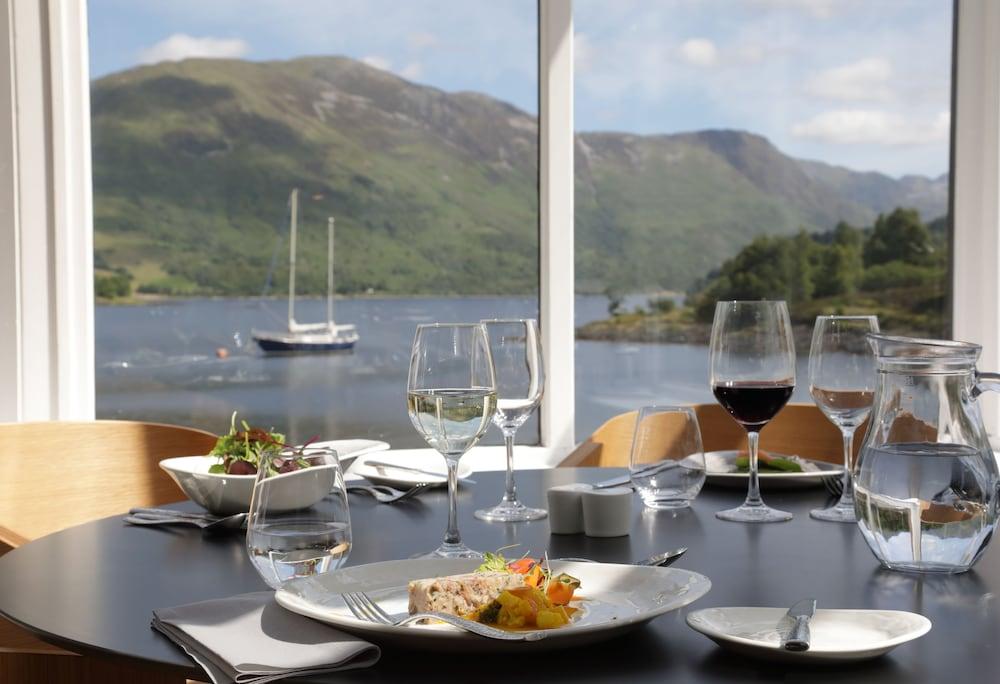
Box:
[0,420,216,684]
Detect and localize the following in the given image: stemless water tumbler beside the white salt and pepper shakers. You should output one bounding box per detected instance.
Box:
[629,406,705,509]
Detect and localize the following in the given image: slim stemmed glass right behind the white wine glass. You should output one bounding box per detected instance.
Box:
[476,319,548,522]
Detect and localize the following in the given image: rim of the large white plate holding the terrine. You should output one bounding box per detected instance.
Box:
[274,559,712,643]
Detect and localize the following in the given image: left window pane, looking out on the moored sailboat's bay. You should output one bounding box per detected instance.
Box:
[88,0,538,447]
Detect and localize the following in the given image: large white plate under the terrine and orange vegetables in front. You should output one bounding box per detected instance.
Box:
[275,558,712,653]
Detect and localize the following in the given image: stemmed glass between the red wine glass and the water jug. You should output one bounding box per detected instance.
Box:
[809,316,879,522]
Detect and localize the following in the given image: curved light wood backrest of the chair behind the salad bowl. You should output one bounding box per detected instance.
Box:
[0,420,216,547]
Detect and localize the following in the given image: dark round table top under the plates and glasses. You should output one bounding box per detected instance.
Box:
[0,468,1000,684]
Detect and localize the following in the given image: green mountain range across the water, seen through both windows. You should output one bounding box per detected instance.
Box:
[91,57,947,294]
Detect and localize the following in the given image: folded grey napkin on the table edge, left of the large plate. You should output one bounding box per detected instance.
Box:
[153,591,380,684]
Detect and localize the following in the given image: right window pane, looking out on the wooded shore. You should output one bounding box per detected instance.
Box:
[574,0,952,438]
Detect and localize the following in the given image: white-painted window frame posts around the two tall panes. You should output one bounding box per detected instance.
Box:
[0,0,1000,454]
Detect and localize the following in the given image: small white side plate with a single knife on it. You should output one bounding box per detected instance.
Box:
[687,608,931,663]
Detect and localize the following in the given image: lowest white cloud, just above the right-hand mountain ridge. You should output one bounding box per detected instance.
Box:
[792,109,951,145]
